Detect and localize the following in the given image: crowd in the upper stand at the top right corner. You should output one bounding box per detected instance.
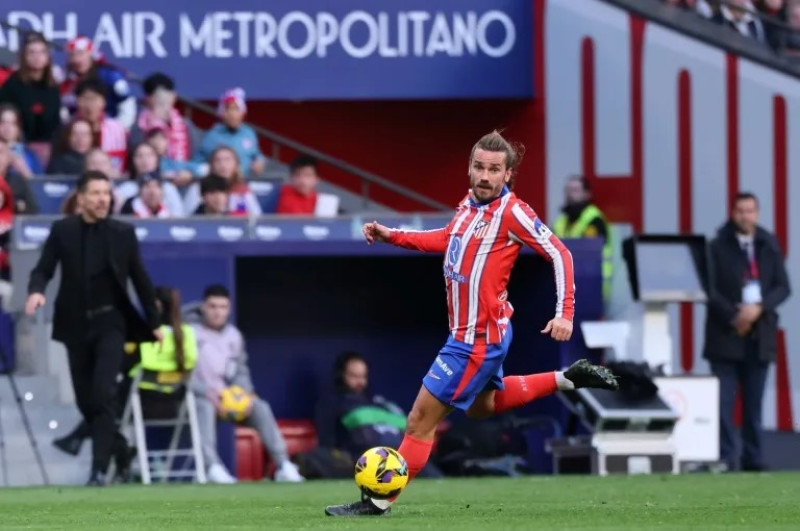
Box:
[664,0,800,54]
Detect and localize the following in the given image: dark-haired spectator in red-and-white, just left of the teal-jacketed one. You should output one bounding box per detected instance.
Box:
[131,72,197,161]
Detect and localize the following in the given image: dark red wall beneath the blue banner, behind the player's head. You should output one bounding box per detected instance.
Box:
[248,101,543,210]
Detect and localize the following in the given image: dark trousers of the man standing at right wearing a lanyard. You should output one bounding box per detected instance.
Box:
[711,339,769,469]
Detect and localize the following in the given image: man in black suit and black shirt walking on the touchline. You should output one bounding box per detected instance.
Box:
[25,171,162,485]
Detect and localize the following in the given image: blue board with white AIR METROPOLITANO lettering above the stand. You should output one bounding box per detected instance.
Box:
[0,0,533,100]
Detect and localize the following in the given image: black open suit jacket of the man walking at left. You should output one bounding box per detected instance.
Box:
[28,216,159,345]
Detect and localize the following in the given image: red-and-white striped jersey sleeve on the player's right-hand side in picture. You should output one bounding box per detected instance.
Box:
[508,202,575,321]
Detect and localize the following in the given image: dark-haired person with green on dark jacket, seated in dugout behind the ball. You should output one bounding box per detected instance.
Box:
[316,352,442,477]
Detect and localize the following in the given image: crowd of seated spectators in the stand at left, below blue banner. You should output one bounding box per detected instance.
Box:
[0,33,339,224]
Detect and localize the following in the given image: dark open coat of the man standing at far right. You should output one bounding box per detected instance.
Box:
[703,222,791,362]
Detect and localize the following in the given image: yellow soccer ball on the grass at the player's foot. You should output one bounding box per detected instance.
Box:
[356,446,408,500]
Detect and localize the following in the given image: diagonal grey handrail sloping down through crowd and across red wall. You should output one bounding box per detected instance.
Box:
[0,20,452,211]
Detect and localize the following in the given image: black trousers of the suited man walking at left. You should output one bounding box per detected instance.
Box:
[67,310,125,473]
